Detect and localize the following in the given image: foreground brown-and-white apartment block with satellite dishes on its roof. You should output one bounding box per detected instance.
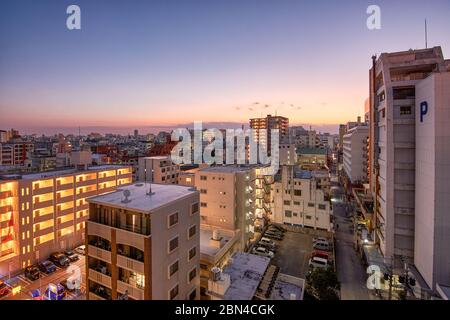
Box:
[85,183,200,300]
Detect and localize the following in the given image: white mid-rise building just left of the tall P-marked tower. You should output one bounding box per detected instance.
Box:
[343,126,369,183]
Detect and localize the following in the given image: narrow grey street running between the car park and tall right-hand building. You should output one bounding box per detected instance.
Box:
[333,183,374,300]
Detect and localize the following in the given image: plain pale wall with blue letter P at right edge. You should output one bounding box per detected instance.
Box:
[414,72,450,292]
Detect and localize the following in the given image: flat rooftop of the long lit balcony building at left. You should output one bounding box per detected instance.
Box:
[0,164,129,180]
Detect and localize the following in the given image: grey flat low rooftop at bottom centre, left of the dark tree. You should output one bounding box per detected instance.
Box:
[223,252,270,300]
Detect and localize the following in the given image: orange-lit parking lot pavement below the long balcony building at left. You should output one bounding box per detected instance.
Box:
[1,255,86,300]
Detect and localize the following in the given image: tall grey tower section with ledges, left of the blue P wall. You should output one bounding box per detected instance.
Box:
[369,47,446,267]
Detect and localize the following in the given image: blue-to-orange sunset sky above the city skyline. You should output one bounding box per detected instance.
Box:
[0,0,450,133]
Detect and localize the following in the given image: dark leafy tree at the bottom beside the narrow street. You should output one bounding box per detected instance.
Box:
[306,268,341,300]
